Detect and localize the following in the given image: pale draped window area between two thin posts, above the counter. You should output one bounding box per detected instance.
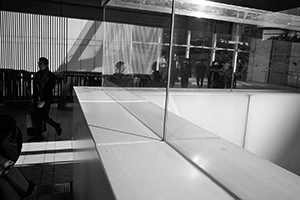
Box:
[103,22,167,87]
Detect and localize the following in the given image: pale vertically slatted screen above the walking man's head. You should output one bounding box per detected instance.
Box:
[0,11,68,72]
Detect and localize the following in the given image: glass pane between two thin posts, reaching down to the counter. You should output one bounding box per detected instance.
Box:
[102,22,169,138]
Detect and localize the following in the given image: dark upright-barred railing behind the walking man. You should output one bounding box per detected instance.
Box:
[0,69,150,109]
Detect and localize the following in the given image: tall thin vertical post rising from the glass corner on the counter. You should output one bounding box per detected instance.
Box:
[162,0,175,141]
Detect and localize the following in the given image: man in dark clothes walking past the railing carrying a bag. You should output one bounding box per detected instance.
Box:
[29,57,62,141]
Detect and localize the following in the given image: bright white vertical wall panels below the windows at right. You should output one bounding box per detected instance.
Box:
[137,90,300,175]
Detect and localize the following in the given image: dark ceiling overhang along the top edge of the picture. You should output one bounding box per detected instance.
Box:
[0,0,300,26]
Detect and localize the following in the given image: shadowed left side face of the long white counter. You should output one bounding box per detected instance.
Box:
[73,94,115,200]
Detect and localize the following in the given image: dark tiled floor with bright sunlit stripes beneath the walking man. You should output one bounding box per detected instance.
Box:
[0,104,75,200]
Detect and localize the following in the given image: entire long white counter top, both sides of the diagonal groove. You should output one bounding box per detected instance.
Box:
[74,87,300,200]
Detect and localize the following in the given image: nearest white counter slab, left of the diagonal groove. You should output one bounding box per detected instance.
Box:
[97,142,232,200]
